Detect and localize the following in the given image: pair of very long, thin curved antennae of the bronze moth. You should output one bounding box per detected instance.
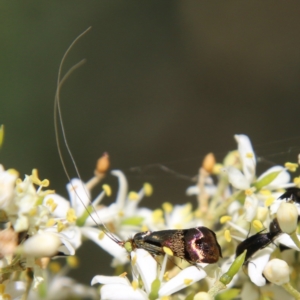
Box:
[54,27,122,245]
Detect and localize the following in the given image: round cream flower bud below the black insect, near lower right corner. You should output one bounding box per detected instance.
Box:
[263,258,290,285]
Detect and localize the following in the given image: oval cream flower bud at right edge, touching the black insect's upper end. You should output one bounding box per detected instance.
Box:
[277,202,298,234]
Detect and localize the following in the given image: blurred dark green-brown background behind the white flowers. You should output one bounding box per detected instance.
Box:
[0,0,300,283]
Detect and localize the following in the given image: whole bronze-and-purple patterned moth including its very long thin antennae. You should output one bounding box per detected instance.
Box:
[54,28,222,264]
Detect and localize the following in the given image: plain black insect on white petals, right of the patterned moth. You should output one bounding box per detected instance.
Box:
[235,219,282,262]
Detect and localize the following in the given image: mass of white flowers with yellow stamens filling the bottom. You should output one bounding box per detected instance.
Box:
[0,135,300,300]
